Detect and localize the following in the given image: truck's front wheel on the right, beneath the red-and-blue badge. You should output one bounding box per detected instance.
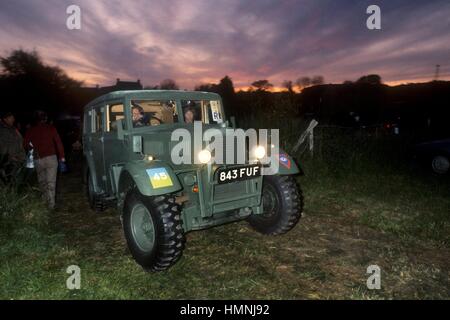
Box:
[248,175,303,235]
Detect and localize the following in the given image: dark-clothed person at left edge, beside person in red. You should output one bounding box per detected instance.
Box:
[0,112,25,180]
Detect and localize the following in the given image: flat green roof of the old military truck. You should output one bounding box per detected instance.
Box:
[86,90,220,108]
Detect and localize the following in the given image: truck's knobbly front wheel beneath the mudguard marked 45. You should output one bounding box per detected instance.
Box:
[122,189,186,271]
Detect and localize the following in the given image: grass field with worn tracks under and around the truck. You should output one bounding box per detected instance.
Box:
[0,132,450,299]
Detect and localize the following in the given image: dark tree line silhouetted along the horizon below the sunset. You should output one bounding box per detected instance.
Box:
[0,50,450,140]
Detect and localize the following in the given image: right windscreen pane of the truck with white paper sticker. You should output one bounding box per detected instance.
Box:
[181,100,223,124]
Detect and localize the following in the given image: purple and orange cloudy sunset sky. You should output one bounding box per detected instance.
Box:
[0,0,450,89]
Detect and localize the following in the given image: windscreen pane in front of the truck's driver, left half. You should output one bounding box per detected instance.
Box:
[130,100,178,128]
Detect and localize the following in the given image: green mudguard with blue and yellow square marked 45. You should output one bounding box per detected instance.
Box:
[119,161,182,196]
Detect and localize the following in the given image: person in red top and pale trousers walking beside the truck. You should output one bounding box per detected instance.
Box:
[25,111,66,209]
